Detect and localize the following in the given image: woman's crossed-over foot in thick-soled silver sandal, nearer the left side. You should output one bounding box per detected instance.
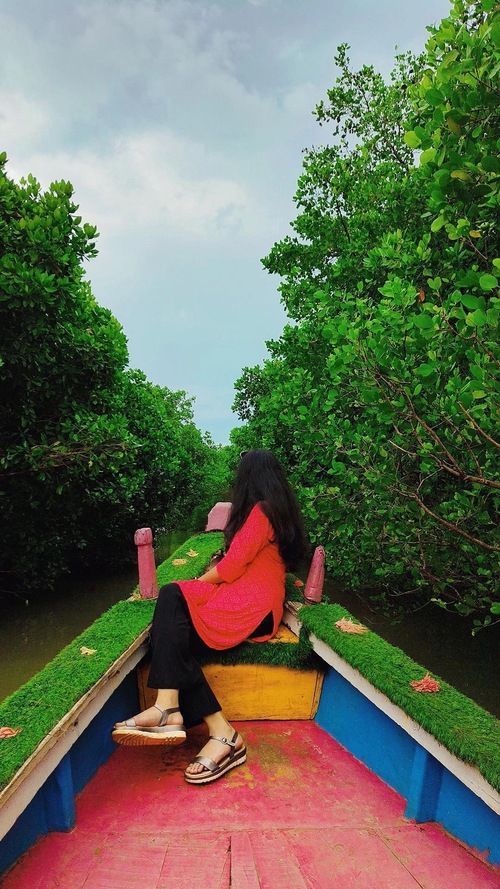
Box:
[112,704,186,746]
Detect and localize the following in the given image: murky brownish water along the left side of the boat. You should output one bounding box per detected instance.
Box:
[0,532,189,700]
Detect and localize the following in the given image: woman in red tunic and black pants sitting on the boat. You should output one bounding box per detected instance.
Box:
[113,450,306,784]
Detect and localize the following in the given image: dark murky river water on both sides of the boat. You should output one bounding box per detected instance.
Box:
[0,532,500,717]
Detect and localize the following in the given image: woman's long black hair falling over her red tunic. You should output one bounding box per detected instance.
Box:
[224,450,307,571]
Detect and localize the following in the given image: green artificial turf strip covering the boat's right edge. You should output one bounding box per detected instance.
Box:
[299,603,500,791]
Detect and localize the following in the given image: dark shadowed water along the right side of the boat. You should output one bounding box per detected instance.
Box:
[324,580,500,717]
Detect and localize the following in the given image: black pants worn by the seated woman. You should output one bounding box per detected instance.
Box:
[148,583,273,728]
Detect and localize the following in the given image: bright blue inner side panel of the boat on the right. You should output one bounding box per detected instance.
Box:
[316,667,500,864]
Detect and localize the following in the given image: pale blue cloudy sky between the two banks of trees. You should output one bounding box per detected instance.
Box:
[0,0,450,444]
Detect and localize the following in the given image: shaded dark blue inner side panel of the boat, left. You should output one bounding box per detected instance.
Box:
[0,671,139,875]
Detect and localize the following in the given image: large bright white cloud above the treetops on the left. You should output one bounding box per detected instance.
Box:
[7,132,257,241]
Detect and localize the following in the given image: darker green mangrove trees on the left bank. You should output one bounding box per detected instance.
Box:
[0,154,230,589]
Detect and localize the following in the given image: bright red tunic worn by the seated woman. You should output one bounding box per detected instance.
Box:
[177,504,285,650]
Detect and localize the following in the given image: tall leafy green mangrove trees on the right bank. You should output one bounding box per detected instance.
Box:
[235,0,500,626]
